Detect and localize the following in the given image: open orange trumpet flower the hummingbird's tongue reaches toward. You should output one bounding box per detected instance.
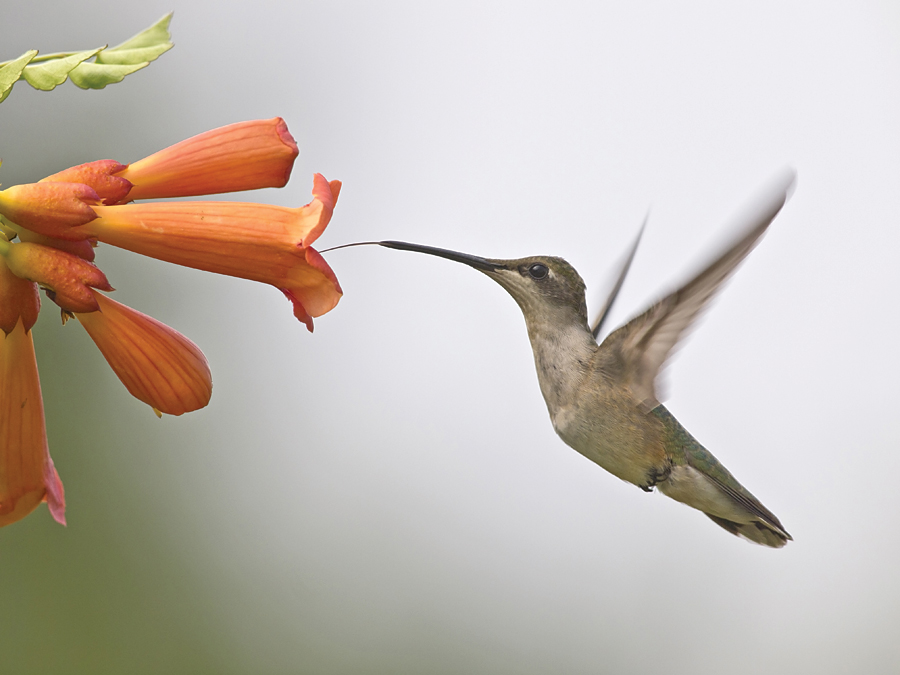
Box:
[86,174,342,326]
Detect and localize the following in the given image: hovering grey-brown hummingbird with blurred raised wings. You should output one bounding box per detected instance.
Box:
[344,173,794,548]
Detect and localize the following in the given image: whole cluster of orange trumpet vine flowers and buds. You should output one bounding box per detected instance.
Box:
[0,118,341,527]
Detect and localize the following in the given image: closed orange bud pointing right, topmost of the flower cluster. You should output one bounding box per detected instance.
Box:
[118,117,300,199]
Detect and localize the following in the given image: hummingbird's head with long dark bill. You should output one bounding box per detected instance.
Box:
[378,241,587,332]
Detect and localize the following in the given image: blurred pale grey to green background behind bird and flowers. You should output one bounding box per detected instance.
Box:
[0,0,900,674]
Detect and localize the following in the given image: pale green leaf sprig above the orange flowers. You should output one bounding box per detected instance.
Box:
[0,12,174,102]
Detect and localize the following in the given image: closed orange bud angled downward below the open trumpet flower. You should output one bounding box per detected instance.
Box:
[75,291,212,415]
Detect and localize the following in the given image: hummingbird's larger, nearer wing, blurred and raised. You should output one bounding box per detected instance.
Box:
[610,171,795,410]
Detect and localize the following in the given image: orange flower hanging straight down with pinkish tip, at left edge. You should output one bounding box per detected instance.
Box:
[0,320,66,527]
